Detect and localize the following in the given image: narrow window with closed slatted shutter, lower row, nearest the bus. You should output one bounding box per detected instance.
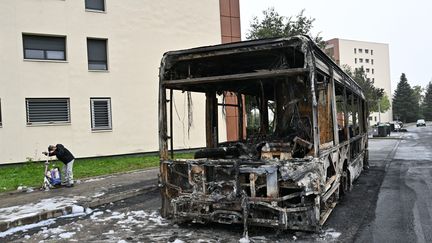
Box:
[90,98,112,131]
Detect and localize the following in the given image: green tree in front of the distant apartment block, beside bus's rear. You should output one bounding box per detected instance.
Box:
[342,65,384,112]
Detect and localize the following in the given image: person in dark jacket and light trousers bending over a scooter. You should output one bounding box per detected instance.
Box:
[43,144,75,187]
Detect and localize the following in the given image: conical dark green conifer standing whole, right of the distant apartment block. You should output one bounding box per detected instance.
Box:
[393,73,419,122]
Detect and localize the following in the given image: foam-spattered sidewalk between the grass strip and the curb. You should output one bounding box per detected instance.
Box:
[0,168,159,234]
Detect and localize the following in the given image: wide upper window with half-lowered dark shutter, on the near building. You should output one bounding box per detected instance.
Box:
[23,34,66,61]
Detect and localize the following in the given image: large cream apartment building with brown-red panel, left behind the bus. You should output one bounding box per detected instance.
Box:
[0,0,240,164]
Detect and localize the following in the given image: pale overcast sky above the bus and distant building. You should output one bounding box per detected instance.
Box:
[240,0,432,93]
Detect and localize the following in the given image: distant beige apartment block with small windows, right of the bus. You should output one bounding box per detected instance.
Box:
[326,38,393,124]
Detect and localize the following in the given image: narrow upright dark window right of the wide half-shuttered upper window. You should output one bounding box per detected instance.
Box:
[87,38,108,70]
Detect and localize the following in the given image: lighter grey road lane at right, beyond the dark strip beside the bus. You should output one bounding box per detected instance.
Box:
[356,124,432,242]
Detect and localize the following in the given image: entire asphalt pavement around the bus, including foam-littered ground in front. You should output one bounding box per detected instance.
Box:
[7,126,432,243]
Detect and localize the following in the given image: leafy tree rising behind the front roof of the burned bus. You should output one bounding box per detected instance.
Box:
[246,7,325,48]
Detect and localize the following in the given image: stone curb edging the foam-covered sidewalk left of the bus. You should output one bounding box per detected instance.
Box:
[0,185,158,232]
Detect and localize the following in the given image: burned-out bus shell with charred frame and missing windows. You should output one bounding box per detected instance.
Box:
[159,36,368,231]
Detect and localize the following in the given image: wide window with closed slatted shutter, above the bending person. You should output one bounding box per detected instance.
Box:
[26,98,71,125]
